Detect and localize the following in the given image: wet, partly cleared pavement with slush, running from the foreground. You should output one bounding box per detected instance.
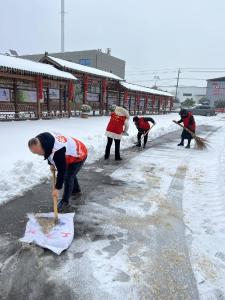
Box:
[0,126,216,300]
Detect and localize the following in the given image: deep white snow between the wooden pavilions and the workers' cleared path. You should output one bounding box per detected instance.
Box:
[0,114,221,203]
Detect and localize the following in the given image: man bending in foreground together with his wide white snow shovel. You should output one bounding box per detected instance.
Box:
[20,132,87,254]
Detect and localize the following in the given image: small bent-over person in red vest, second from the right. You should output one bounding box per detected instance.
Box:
[133,116,155,148]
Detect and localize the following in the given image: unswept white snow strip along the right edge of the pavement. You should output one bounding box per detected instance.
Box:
[183,119,225,300]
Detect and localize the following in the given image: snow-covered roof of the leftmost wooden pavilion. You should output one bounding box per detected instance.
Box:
[0,55,77,80]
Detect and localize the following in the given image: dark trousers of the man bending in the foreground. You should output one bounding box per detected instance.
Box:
[62,158,86,203]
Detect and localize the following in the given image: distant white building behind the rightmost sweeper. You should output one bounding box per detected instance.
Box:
[172,86,206,104]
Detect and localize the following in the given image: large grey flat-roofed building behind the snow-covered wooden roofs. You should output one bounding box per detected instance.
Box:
[21,48,125,78]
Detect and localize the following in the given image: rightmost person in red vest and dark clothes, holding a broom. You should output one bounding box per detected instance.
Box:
[177,108,196,149]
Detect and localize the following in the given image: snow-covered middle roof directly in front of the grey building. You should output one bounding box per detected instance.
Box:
[47,55,123,80]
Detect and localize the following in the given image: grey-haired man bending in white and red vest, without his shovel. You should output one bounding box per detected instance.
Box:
[28,132,88,212]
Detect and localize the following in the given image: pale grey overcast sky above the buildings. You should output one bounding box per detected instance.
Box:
[0,0,225,86]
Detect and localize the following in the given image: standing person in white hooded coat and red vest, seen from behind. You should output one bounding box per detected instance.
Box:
[105,106,130,160]
